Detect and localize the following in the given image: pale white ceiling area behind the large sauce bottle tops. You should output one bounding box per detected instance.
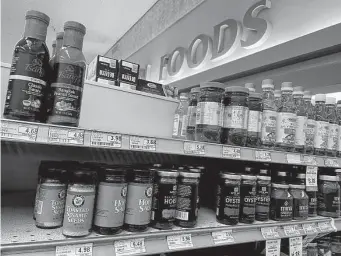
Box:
[1,0,157,63]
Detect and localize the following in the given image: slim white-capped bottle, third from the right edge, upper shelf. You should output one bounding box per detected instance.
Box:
[314,94,329,156]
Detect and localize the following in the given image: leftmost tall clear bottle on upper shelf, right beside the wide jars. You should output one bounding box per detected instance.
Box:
[261,79,277,149]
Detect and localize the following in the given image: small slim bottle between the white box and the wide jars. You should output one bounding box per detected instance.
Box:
[173,93,189,139]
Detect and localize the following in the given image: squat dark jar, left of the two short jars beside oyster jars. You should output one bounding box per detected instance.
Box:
[270,183,294,221]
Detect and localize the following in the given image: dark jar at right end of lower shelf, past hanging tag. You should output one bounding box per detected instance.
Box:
[317,175,340,218]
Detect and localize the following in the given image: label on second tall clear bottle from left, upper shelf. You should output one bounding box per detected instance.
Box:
[276,112,297,146]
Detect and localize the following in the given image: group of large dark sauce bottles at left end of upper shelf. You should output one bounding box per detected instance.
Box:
[4,10,86,126]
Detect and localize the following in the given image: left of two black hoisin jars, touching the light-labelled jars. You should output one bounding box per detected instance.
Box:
[151,170,179,229]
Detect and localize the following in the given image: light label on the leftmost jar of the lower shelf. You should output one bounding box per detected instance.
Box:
[35,183,66,227]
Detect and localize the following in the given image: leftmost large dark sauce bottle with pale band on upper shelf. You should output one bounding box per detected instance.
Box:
[4,10,50,122]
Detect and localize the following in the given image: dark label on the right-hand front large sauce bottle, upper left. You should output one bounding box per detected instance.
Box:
[51,63,84,119]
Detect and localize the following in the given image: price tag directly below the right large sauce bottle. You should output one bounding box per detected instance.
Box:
[47,127,84,145]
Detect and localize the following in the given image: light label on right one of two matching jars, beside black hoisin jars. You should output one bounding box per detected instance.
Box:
[124,182,153,225]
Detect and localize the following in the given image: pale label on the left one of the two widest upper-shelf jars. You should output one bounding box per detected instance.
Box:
[196,102,223,126]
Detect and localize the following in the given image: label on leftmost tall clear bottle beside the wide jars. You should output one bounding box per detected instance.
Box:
[261,110,277,144]
